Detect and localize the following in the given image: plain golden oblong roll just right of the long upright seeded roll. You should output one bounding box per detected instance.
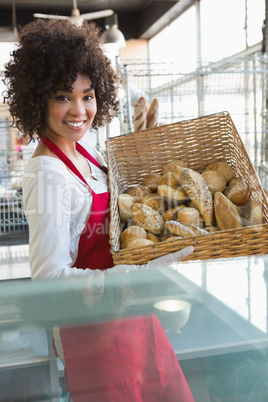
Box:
[214,191,243,230]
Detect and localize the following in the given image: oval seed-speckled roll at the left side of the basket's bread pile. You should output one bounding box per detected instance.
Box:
[131,203,165,235]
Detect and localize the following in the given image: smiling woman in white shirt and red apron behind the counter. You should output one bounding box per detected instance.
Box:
[2,20,193,402]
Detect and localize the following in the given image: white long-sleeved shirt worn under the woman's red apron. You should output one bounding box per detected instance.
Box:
[23,143,114,279]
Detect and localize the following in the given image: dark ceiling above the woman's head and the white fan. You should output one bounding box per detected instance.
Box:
[0,0,194,40]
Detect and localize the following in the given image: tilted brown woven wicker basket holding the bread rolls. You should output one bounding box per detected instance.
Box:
[107,112,268,264]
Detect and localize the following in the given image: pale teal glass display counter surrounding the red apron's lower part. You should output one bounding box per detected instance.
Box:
[0,256,268,402]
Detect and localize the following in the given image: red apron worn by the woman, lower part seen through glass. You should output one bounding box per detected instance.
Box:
[42,137,194,402]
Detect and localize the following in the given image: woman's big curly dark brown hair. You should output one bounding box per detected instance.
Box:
[3,19,119,139]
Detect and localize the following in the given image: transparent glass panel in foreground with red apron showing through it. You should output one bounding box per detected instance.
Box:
[0,256,268,402]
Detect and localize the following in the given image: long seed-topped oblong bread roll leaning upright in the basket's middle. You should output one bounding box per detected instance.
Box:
[176,166,214,226]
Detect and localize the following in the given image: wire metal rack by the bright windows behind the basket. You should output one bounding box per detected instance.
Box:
[119,50,268,187]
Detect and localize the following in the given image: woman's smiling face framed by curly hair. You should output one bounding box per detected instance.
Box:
[46,74,97,142]
